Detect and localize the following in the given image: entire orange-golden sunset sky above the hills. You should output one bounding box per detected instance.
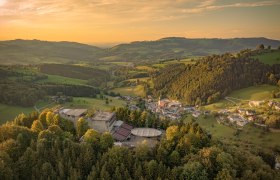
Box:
[0,0,280,43]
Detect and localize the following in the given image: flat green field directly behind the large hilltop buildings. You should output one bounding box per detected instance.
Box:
[62,97,126,111]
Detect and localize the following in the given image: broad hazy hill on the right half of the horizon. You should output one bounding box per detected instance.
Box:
[103,37,280,61]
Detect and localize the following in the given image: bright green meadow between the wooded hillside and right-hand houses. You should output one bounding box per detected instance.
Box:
[205,85,277,110]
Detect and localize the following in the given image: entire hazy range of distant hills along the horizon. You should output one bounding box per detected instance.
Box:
[0,37,280,64]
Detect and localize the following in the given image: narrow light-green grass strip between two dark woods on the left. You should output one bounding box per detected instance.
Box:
[37,75,87,85]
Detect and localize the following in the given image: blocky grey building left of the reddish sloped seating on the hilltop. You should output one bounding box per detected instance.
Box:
[87,111,116,133]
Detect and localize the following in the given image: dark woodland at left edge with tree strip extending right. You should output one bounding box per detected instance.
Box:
[0,66,100,107]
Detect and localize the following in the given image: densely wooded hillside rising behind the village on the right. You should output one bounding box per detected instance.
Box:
[153,54,280,105]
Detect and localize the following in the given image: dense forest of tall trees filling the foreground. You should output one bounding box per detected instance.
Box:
[0,109,280,180]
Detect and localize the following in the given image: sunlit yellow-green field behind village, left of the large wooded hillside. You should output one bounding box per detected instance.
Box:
[113,85,145,97]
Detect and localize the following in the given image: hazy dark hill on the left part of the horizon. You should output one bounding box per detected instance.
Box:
[0,39,103,64]
